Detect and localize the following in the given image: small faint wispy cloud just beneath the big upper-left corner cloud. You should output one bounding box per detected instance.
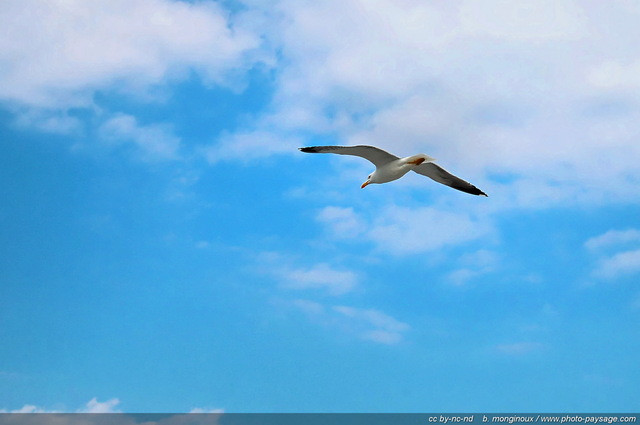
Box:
[99,114,180,161]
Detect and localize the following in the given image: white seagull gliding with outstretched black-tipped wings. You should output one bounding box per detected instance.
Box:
[298,145,488,196]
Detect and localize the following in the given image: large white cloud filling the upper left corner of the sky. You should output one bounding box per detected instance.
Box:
[0,0,260,108]
